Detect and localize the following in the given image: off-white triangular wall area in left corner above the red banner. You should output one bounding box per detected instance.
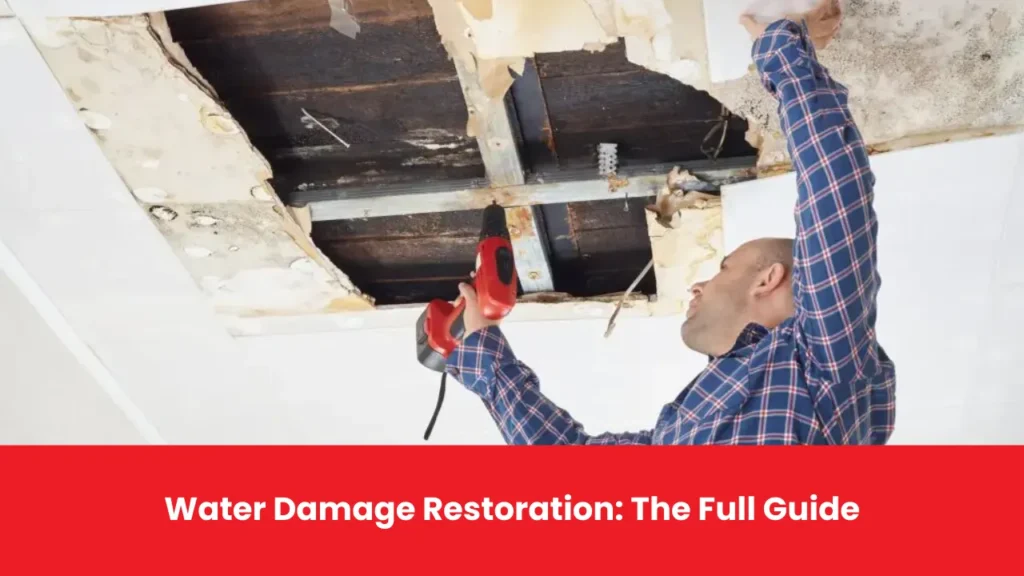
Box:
[0,272,147,444]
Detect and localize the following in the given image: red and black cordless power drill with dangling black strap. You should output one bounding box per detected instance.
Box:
[416,203,519,440]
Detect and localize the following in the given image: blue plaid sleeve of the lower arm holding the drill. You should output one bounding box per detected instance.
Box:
[447,326,652,445]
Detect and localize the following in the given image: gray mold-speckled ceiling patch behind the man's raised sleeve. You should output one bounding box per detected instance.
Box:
[710,0,1024,166]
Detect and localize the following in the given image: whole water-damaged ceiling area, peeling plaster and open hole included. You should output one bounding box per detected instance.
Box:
[15,0,1024,323]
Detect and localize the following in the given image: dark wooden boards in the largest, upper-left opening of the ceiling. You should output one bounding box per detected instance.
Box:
[168,0,483,196]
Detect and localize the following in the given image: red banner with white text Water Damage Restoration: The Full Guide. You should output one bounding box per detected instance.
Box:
[0,447,1024,576]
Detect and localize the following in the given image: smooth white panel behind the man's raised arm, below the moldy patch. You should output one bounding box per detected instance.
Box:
[723,135,1024,444]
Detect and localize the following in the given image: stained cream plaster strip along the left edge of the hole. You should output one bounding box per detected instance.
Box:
[30,16,372,316]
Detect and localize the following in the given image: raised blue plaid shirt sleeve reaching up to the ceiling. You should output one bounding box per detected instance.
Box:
[754,19,881,383]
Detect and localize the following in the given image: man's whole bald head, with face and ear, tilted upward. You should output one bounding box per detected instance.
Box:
[682,238,794,356]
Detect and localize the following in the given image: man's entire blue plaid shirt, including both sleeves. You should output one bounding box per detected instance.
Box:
[447,20,895,445]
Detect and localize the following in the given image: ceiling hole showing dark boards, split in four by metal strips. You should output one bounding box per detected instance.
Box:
[159,0,756,305]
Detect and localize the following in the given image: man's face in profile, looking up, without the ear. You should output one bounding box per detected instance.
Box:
[681,245,755,356]
